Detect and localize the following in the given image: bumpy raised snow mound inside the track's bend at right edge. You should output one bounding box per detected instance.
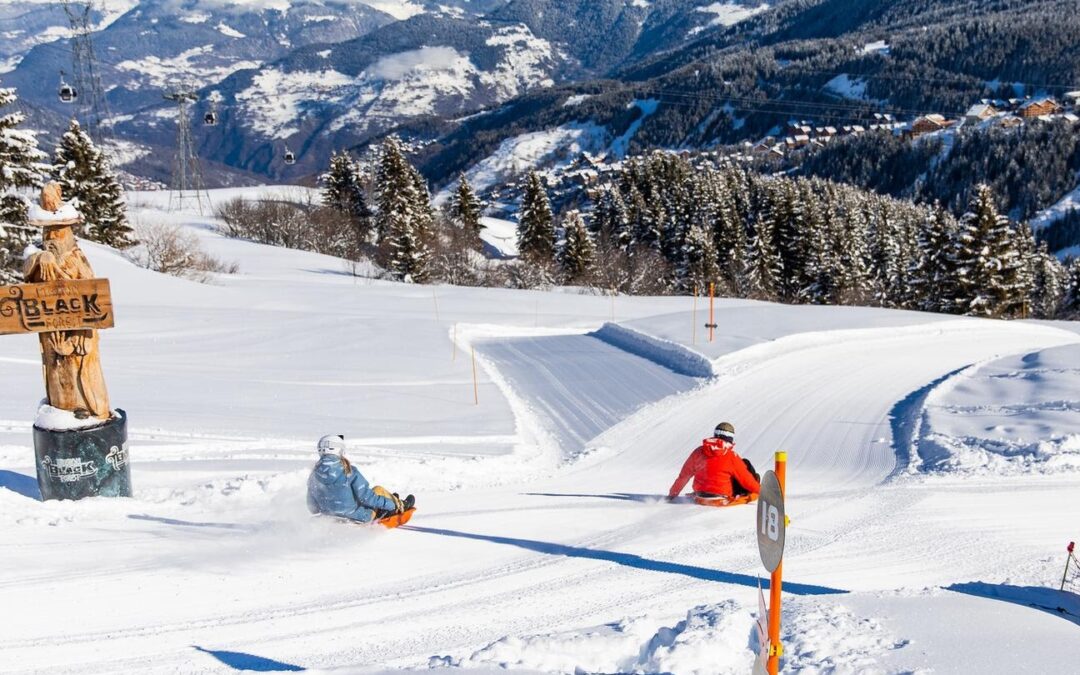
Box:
[908,345,1080,474]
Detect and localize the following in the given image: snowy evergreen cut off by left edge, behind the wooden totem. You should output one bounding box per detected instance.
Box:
[0,82,48,284]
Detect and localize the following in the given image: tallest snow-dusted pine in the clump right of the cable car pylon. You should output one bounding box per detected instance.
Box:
[375,136,433,283]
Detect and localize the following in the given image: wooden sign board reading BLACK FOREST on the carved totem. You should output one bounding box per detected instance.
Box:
[0,279,112,335]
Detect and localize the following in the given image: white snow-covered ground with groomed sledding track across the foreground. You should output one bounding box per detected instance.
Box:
[0,185,1080,674]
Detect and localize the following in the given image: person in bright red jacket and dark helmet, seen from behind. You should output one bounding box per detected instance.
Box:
[667,422,761,500]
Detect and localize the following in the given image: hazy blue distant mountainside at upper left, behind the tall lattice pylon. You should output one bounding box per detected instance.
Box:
[4,0,394,130]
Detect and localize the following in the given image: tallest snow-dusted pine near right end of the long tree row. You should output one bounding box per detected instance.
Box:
[957,185,1026,318]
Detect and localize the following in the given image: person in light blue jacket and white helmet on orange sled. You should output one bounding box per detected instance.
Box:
[308,436,416,523]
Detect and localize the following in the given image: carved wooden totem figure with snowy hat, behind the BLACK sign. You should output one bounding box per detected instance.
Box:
[23,183,111,420]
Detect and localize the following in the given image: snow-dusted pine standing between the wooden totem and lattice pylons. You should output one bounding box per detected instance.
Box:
[52,120,135,248]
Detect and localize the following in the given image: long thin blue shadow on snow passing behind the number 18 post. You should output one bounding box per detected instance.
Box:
[402,525,847,595]
